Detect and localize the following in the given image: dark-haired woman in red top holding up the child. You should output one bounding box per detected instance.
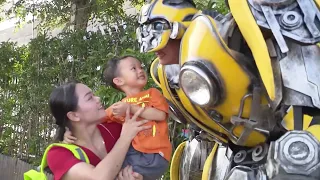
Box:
[47,83,150,180]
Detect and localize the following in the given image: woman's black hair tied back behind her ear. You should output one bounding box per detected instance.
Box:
[49,82,78,142]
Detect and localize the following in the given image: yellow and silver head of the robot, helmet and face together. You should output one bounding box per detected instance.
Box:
[136,0,198,52]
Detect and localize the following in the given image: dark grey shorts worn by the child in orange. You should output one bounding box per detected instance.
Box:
[122,146,169,180]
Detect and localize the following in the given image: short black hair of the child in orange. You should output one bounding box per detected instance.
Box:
[103,55,137,90]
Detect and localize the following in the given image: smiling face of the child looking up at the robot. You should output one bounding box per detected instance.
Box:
[118,57,148,88]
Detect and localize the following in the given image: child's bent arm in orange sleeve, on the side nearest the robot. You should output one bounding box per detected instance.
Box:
[130,88,169,121]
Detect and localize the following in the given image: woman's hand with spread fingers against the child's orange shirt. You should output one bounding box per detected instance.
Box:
[120,108,151,141]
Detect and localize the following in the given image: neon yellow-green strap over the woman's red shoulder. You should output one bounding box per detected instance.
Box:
[24,143,90,180]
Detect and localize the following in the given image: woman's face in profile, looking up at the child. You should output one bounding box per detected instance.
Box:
[75,83,106,123]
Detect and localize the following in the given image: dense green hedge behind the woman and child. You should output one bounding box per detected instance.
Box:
[0,14,149,164]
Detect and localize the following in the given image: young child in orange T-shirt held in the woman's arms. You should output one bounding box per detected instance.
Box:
[63,56,172,180]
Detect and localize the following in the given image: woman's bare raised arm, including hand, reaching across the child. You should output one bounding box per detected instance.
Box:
[62,108,151,180]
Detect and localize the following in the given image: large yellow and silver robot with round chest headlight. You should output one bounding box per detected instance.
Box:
[137,0,320,180]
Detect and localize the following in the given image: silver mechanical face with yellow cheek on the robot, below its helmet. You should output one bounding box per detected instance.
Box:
[136,19,171,52]
